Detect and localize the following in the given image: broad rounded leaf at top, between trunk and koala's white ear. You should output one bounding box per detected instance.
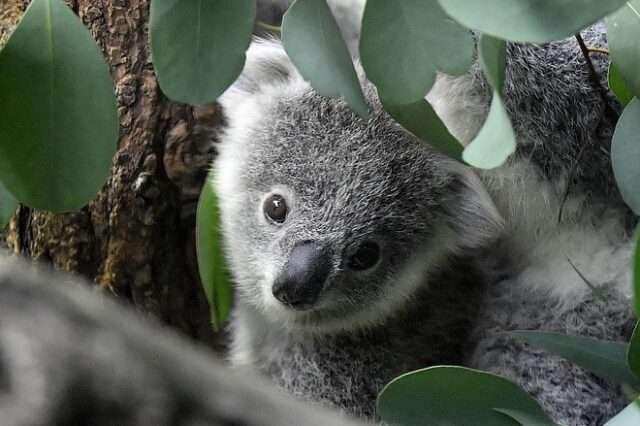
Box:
[149,0,256,104]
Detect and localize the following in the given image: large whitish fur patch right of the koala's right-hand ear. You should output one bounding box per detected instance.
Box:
[482,161,632,308]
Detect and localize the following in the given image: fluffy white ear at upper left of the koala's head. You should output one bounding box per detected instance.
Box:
[218,39,299,108]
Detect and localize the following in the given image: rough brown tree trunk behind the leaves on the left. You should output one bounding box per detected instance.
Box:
[0,0,219,350]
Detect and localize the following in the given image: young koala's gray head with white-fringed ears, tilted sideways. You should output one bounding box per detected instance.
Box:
[215,41,501,333]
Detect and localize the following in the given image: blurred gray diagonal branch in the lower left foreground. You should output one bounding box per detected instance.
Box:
[0,256,364,426]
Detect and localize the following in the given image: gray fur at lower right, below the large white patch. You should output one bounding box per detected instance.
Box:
[470,282,635,425]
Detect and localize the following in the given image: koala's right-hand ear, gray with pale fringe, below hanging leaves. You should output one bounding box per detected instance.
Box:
[445,166,505,248]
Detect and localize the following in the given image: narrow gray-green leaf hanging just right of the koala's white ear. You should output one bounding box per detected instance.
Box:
[282,0,369,118]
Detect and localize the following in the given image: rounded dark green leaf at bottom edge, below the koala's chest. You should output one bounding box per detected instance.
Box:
[378,366,555,426]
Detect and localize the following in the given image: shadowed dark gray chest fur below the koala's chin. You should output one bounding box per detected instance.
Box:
[234,259,486,418]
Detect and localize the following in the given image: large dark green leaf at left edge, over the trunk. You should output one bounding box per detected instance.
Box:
[0,0,118,212]
